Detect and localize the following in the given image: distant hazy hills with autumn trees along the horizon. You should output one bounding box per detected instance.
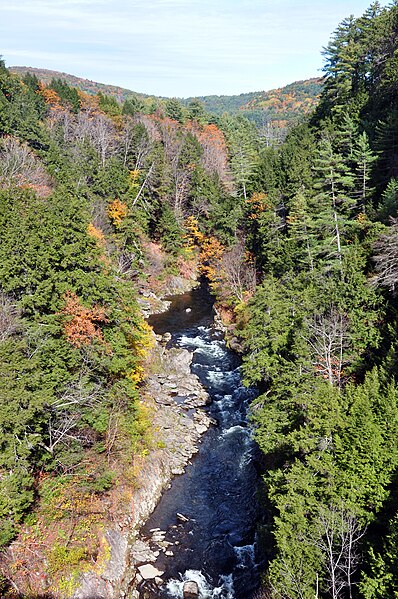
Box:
[10,66,322,126]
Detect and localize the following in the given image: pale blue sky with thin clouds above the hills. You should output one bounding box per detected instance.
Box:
[0,0,380,97]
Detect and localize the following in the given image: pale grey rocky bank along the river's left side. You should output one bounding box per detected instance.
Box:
[73,281,212,599]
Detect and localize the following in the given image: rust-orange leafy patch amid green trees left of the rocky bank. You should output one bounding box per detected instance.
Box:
[62,291,108,347]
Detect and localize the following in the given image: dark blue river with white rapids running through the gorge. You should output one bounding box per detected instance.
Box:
[142,287,258,599]
